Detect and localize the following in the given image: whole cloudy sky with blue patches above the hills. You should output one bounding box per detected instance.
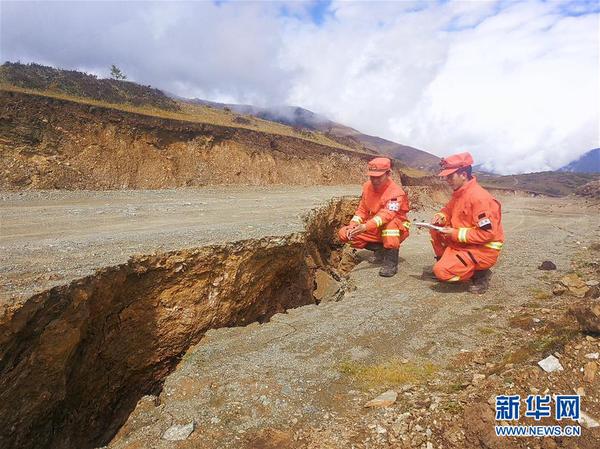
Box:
[0,0,600,173]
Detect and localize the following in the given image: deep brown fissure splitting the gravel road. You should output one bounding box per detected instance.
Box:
[0,198,356,449]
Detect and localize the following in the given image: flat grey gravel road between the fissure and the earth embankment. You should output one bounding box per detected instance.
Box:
[0,186,360,304]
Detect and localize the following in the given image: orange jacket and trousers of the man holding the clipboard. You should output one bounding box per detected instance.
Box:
[431,177,504,282]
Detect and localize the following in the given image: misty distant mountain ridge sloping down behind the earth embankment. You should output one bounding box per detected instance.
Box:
[185,99,440,171]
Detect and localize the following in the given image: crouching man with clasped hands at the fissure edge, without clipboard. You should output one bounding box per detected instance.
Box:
[338,157,410,277]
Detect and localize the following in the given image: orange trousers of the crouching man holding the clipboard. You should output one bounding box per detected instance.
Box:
[433,238,500,282]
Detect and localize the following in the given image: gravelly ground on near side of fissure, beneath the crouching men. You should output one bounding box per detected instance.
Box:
[110,196,600,449]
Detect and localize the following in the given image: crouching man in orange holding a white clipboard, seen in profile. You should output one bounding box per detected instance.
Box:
[431,153,504,293]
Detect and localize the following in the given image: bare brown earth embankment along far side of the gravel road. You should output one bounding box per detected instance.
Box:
[0,91,431,190]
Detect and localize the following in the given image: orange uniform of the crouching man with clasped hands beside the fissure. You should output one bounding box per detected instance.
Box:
[338,179,410,249]
